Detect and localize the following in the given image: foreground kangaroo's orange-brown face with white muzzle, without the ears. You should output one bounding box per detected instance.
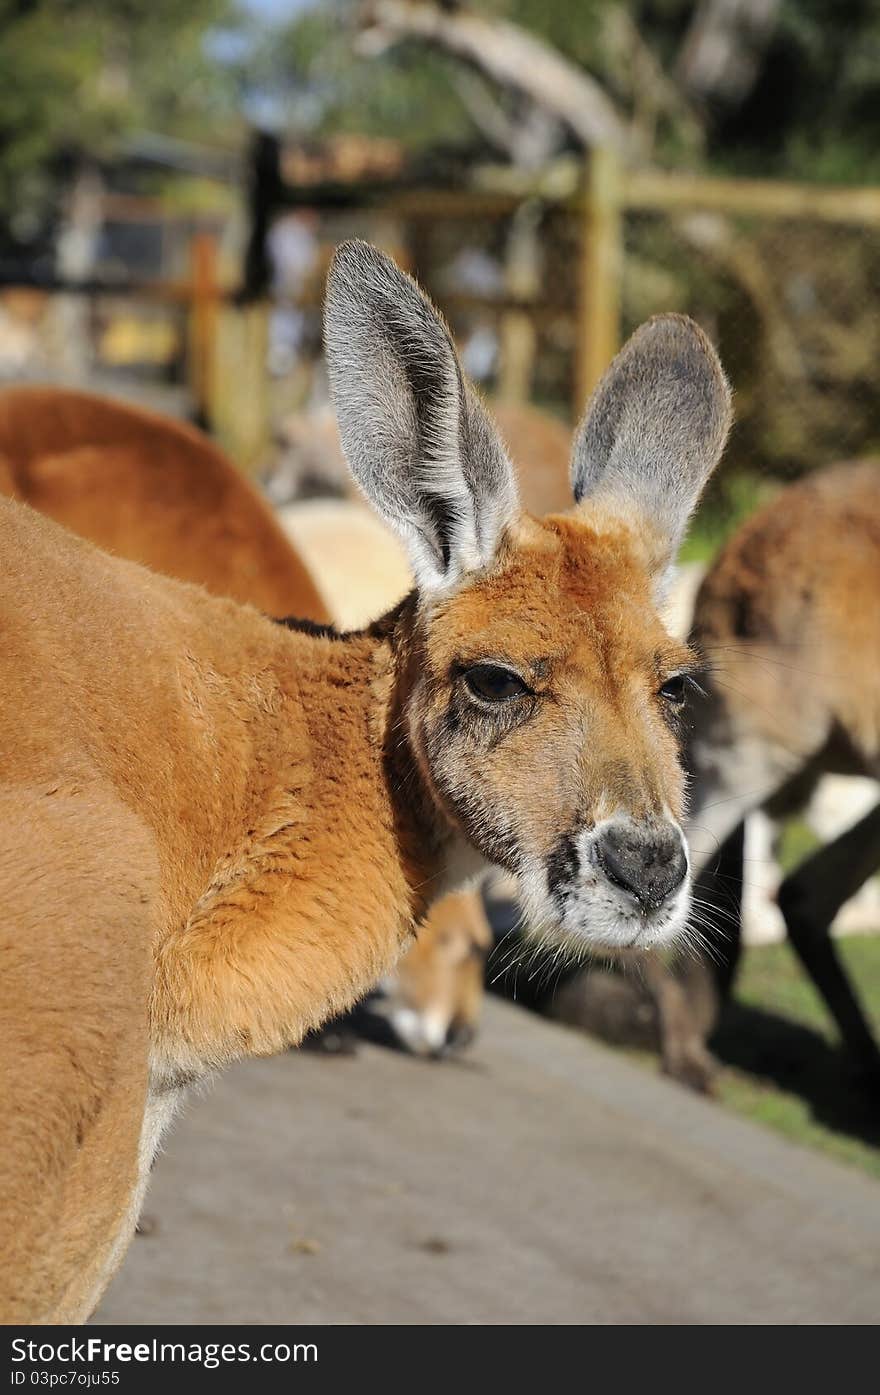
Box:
[410,516,693,946]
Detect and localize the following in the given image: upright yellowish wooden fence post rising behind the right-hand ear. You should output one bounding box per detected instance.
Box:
[572,149,623,420]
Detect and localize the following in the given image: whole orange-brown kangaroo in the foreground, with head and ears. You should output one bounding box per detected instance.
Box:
[0,244,729,1321]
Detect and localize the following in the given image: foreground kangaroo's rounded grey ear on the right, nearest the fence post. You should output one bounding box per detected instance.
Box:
[572,315,731,545]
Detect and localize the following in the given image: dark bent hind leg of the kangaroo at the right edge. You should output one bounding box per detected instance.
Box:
[778,804,880,1084]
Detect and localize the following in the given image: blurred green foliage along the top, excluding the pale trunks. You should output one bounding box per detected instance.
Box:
[0,0,880,222]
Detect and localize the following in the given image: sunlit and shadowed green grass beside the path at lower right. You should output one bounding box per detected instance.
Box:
[713,936,880,1177]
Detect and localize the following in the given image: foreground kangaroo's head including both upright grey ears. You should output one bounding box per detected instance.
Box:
[325,243,731,946]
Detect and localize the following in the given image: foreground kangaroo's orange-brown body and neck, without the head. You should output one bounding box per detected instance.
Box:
[0,502,432,1320]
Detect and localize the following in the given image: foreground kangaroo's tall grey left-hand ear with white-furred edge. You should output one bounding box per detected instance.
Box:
[324,241,517,591]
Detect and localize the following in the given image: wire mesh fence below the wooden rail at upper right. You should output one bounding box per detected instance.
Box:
[622,203,880,478]
